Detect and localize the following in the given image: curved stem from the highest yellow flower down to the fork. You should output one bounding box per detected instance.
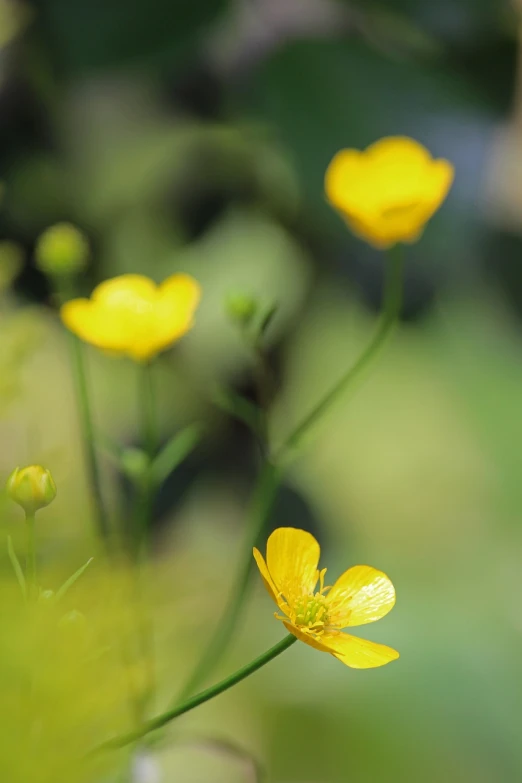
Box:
[276,245,404,463]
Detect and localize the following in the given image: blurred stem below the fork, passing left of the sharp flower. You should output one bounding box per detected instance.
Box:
[176,462,281,704]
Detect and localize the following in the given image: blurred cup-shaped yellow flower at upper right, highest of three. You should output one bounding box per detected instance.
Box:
[325,136,454,248]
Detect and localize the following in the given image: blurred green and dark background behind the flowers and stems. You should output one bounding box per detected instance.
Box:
[0,0,522,783]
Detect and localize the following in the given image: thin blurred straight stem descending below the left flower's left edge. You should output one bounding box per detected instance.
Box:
[68,332,110,542]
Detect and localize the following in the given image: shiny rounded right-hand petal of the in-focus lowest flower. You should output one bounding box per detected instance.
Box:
[326,566,395,628]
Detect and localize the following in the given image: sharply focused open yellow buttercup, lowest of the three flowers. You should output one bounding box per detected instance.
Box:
[254,527,399,669]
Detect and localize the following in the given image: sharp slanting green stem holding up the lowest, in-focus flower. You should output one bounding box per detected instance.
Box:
[96,634,297,750]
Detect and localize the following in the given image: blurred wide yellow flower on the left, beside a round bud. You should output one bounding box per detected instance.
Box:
[60,274,200,361]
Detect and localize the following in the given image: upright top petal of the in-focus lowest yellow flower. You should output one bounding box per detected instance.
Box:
[266,527,320,606]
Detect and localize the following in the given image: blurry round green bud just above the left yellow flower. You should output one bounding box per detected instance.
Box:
[35,223,89,275]
